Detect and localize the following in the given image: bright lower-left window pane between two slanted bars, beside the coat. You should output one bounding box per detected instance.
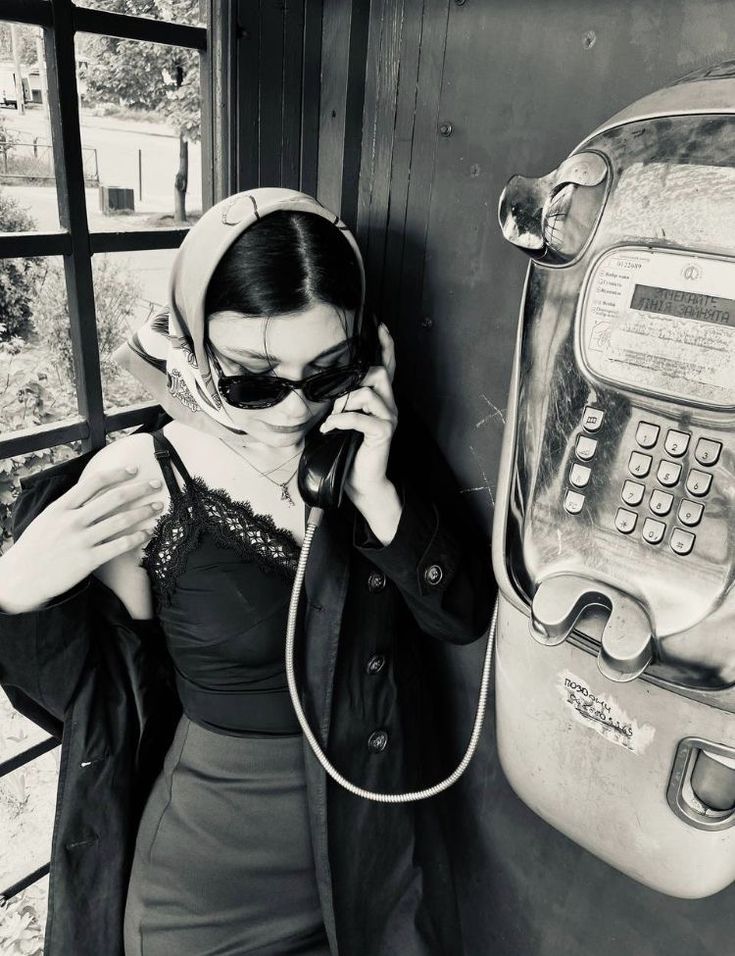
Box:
[0,747,61,886]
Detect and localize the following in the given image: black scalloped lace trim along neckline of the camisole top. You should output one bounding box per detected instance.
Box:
[139,475,301,608]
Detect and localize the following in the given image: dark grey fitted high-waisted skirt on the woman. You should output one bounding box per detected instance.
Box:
[124,715,330,956]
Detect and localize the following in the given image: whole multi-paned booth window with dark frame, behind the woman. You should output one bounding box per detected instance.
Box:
[0,0,234,928]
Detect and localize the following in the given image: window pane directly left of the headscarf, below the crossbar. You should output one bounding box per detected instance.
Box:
[92,249,176,411]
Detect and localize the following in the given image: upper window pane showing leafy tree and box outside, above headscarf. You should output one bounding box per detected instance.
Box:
[77,34,202,232]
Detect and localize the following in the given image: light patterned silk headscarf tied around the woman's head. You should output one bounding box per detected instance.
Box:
[112,188,365,441]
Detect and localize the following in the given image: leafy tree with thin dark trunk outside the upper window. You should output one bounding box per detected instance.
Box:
[82,0,201,223]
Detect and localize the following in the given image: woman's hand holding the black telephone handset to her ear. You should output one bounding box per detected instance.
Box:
[319,322,401,544]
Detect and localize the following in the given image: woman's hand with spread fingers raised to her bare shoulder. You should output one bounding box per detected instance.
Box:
[0,467,163,613]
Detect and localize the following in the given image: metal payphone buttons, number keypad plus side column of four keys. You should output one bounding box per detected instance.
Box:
[564,406,722,556]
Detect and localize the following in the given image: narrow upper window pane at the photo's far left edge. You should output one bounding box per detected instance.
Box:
[0,21,60,232]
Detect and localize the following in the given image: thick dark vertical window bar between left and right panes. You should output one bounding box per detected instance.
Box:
[44,0,105,453]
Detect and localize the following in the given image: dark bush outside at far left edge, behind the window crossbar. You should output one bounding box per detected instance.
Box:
[0,190,43,342]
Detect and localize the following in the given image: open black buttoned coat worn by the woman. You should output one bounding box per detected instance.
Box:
[0,396,496,956]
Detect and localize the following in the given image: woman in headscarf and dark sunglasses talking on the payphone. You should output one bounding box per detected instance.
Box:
[0,190,493,956]
